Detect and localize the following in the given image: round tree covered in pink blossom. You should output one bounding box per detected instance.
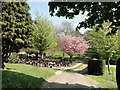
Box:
[59,35,90,58]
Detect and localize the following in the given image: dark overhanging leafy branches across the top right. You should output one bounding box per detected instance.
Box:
[48,1,120,33]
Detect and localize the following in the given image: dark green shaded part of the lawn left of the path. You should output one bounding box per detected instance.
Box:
[2,70,45,88]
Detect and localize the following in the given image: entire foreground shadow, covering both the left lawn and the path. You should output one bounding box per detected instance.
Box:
[2,70,117,90]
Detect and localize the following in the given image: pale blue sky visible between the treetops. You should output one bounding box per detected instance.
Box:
[27,1,88,33]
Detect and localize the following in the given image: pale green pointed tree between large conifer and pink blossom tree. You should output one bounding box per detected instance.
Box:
[31,11,57,58]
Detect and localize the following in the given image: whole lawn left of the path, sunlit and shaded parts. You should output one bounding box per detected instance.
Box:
[2,63,56,88]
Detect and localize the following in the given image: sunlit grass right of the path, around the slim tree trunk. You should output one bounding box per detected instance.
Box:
[86,65,117,89]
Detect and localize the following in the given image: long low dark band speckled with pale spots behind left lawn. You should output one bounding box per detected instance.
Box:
[13,59,76,68]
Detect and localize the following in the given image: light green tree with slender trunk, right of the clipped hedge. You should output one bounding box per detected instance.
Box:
[86,22,118,73]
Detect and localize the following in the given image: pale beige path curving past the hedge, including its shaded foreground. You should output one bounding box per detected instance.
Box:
[42,64,98,90]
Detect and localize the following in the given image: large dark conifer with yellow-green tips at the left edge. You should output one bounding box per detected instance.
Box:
[1,2,32,68]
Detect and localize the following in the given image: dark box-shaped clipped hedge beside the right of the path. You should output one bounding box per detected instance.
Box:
[88,59,105,75]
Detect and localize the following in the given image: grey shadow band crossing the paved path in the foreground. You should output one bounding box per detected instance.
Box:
[41,81,105,90]
